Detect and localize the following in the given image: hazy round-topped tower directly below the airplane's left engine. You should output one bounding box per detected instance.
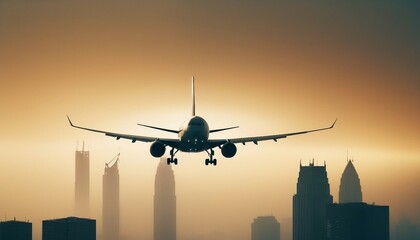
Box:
[153,158,176,240]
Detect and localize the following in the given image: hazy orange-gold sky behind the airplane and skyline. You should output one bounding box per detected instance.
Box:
[0,0,420,240]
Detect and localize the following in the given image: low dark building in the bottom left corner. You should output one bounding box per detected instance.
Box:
[0,220,32,240]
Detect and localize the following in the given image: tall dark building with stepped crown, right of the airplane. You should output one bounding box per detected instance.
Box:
[293,162,333,240]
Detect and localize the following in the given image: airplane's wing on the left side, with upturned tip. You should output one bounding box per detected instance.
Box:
[67,116,180,148]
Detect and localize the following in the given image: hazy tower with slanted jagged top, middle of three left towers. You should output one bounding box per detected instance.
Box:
[102,154,120,240]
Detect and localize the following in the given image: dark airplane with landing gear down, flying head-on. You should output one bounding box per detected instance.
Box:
[67,77,337,166]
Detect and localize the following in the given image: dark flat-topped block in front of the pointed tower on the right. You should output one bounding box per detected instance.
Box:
[327,203,389,240]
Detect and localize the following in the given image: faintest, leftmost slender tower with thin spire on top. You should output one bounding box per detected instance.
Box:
[75,143,89,217]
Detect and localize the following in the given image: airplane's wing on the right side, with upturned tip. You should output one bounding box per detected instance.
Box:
[209,119,337,147]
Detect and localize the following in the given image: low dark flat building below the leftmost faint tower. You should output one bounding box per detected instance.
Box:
[42,217,96,240]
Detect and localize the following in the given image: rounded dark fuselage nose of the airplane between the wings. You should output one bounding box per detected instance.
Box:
[178,116,210,152]
